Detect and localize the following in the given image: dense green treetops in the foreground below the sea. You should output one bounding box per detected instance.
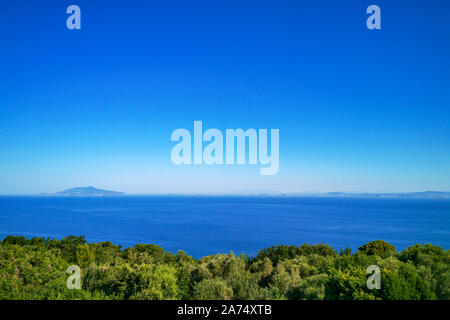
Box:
[0,236,450,300]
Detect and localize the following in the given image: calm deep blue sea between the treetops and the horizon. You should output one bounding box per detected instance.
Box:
[0,196,450,258]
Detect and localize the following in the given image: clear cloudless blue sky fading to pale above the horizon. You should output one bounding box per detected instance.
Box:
[0,0,450,194]
